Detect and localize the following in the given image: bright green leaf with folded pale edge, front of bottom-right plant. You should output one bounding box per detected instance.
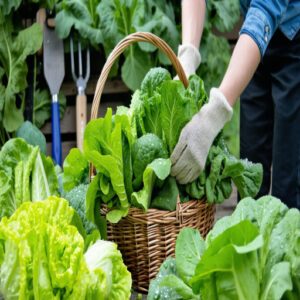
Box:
[191,220,263,299]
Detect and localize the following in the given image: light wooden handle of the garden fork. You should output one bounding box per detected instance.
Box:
[76,94,87,151]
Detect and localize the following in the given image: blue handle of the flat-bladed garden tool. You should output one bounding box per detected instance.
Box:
[51,95,62,166]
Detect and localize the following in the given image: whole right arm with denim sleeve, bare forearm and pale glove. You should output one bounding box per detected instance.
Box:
[171,0,289,184]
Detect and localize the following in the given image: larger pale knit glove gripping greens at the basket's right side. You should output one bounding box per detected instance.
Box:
[171,88,232,184]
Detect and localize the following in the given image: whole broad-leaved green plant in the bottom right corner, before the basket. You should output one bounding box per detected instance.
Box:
[148,196,300,300]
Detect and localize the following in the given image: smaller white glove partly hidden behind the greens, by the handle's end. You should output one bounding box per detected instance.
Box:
[177,44,201,78]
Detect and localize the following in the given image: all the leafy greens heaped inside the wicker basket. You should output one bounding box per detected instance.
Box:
[63,68,262,223]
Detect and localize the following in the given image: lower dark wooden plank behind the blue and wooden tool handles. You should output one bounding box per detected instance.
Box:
[42,101,124,134]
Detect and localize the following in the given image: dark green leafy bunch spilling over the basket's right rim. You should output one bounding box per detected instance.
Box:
[185,142,263,203]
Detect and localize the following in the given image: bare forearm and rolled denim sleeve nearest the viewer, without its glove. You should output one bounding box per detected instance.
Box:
[219,0,289,106]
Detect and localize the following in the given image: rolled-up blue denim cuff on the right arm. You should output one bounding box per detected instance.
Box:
[240,7,274,57]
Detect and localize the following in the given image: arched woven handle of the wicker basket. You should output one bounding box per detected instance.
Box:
[91,32,188,120]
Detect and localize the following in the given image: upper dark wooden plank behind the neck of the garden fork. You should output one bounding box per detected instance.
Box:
[61,77,129,96]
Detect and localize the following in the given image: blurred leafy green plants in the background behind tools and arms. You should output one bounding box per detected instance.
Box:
[0,0,240,156]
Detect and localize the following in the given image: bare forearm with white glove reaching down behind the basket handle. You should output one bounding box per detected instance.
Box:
[177,0,206,77]
